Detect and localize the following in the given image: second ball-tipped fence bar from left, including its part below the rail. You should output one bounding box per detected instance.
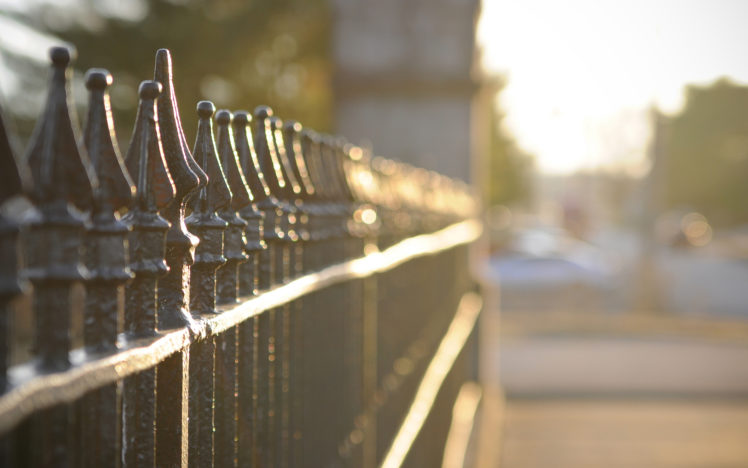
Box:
[78,69,135,467]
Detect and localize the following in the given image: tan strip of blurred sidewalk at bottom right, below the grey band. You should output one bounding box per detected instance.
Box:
[498,399,748,468]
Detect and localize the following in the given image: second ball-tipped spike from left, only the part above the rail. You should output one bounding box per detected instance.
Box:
[83,69,135,352]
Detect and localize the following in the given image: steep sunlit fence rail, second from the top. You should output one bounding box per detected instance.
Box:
[380,293,483,468]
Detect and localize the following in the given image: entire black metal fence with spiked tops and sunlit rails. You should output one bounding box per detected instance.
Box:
[0,48,480,467]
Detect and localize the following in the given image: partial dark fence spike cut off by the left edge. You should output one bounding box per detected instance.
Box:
[0,103,26,393]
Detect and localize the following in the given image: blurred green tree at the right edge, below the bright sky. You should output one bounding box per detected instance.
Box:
[660,78,748,226]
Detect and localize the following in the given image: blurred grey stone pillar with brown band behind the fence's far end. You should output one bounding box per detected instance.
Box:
[333,0,490,181]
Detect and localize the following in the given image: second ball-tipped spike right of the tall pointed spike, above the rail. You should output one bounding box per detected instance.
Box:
[216,110,252,304]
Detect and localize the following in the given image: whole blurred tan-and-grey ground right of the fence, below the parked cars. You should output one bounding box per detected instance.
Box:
[476,309,748,468]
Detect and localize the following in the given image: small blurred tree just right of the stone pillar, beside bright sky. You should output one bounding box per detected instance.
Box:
[486,99,533,206]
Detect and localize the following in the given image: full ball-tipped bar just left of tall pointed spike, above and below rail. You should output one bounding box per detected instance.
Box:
[122,81,175,466]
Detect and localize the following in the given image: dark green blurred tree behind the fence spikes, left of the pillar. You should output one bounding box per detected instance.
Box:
[2,0,332,146]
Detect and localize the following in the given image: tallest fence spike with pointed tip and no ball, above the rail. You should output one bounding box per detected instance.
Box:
[154,49,208,329]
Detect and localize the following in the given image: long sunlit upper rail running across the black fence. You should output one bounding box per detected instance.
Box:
[0,219,482,434]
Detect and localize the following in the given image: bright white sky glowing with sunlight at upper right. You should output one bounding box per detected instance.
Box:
[478,0,748,173]
